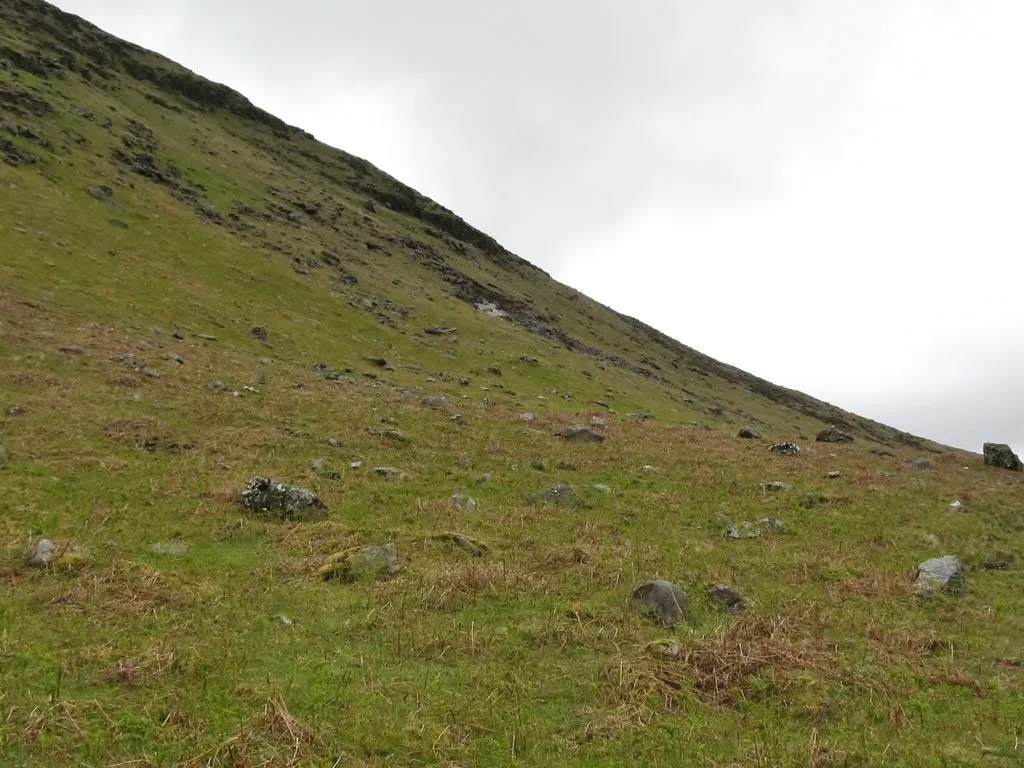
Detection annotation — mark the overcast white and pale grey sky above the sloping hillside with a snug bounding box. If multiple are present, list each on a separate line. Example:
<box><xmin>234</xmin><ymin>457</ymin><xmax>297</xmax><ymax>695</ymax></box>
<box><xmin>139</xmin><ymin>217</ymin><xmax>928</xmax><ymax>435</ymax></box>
<box><xmin>57</xmin><ymin>0</ymin><xmax>1024</xmax><ymax>452</ymax></box>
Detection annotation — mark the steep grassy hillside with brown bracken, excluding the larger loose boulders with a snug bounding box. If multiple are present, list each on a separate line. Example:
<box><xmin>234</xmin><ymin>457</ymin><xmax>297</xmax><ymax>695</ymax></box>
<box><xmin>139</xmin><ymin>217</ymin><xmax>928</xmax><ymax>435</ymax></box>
<box><xmin>0</xmin><ymin>0</ymin><xmax>1024</xmax><ymax>767</ymax></box>
